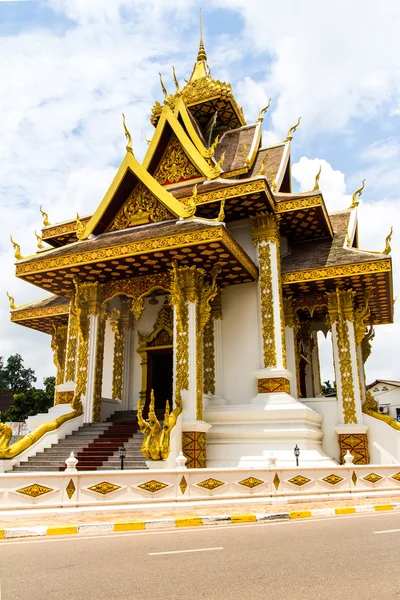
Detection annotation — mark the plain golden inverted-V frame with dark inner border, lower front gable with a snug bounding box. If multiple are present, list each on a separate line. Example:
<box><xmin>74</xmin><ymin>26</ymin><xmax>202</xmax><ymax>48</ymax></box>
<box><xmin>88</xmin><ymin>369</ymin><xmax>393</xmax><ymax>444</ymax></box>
<box><xmin>80</xmin><ymin>152</ymin><xmax>189</xmax><ymax>240</ymax></box>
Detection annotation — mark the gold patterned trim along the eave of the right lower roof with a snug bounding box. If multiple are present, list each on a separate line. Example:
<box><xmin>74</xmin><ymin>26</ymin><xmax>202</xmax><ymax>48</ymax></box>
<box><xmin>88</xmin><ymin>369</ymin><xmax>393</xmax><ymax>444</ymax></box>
<box><xmin>282</xmin><ymin>259</ymin><xmax>392</xmax><ymax>285</ymax></box>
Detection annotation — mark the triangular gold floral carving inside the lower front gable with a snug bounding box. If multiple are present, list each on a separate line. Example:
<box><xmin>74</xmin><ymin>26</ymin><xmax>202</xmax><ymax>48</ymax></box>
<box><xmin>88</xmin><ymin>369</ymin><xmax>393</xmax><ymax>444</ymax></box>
<box><xmin>108</xmin><ymin>182</ymin><xmax>174</xmax><ymax>231</ymax></box>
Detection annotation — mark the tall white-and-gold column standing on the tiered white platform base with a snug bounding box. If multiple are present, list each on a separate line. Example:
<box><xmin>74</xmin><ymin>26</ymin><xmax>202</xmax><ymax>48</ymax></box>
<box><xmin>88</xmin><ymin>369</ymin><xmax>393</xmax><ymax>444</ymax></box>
<box><xmin>251</xmin><ymin>213</ymin><xmax>290</xmax><ymax>393</ymax></box>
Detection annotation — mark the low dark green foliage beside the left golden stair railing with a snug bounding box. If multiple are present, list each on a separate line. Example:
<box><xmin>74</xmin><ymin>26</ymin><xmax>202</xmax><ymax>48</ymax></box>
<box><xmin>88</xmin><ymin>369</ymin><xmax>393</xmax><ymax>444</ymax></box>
<box><xmin>1</xmin><ymin>377</ymin><xmax>56</xmax><ymax>422</ymax></box>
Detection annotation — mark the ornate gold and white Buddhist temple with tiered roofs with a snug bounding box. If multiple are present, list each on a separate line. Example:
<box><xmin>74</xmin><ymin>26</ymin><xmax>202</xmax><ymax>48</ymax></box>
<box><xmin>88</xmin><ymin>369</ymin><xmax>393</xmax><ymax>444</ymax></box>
<box><xmin>5</xmin><ymin>27</ymin><xmax>398</xmax><ymax>468</ymax></box>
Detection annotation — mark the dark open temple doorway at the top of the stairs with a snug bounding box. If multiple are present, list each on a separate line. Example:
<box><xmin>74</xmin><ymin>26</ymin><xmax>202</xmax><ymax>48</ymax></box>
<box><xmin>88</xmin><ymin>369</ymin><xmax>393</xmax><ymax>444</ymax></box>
<box><xmin>145</xmin><ymin>348</ymin><xmax>173</xmax><ymax>415</ymax></box>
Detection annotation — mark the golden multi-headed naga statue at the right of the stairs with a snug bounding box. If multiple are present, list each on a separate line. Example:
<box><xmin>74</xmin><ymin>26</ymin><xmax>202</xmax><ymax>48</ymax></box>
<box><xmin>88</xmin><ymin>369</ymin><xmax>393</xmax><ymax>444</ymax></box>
<box><xmin>137</xmin><ymin>390</ymin><xmax>182</xmax><ymax>460</ymax></box>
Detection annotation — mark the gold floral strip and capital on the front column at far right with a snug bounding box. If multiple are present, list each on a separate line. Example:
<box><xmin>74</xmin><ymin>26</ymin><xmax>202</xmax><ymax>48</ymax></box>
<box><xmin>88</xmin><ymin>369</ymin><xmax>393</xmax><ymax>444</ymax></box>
<box><xmin>327</xmin><ymin>289</ymin><xmax>357</xmax><ymax>424</ymax></box>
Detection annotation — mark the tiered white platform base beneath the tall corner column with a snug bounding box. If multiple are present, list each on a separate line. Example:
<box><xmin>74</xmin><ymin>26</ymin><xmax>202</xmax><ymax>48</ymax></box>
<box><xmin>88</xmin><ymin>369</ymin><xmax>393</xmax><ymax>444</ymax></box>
<box><xmin>204</xmin><ymin>398</ymin><xmax>337</xmax><ymax>468</ymax></box>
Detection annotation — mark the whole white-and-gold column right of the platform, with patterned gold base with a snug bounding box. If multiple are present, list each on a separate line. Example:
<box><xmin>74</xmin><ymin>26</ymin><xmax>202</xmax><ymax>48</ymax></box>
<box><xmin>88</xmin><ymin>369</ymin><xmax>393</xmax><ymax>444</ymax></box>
<box><xmin>327</xmin><ymin>288</ymin><xmax>369</xmax><ymax>464</ymax></box>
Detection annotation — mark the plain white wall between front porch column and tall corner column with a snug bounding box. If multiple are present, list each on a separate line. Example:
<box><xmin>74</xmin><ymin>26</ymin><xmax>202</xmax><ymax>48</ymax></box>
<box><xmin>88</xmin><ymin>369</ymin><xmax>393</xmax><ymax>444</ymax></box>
<box><xmin>222</xmin><ymin>283</ymin><xmax>259</xmax><ymax>404</ymax></box>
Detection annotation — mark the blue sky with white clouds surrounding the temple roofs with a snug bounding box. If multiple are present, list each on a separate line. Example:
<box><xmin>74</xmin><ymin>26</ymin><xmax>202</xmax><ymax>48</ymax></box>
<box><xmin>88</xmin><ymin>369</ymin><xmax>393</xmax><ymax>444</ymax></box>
<box><xmin>0</xmin><ymin>0</ymin><xmax>400</xmax><ymax>384</ymax></box>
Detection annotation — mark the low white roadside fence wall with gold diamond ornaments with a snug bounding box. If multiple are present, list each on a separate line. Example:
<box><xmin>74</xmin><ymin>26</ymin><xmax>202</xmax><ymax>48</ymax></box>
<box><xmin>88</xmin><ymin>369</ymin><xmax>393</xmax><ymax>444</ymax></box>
<box><xmin>0</xmin><ymin>465</ymin><xmax>400</xmax><ymax>510</ymax></box>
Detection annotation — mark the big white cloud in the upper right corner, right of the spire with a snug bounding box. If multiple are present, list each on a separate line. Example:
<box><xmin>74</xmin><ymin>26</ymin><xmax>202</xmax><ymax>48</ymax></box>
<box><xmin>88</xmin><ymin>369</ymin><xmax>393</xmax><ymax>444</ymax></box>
<box><xmin>216</xmin><ymin>0</ymin><xmax>400</xmax><ymax>136</ymax></box>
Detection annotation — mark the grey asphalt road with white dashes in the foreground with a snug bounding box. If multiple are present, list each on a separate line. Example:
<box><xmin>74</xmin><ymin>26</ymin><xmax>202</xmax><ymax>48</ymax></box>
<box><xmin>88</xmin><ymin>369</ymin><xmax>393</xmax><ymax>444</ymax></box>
<box><xmin>0</xmin><ymin>513</ymin><xmax>400</xmax><ymax>600</ymax></box>
